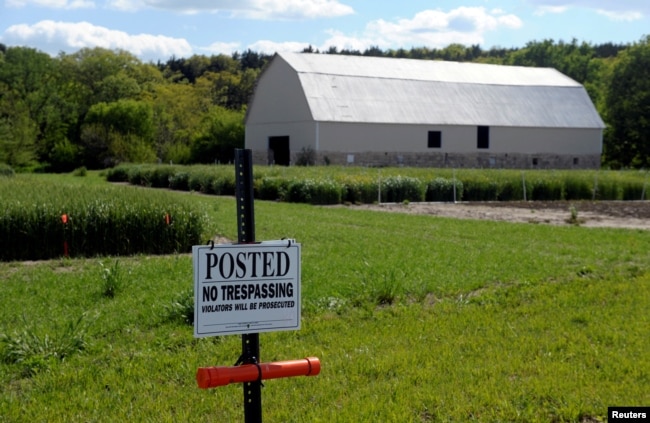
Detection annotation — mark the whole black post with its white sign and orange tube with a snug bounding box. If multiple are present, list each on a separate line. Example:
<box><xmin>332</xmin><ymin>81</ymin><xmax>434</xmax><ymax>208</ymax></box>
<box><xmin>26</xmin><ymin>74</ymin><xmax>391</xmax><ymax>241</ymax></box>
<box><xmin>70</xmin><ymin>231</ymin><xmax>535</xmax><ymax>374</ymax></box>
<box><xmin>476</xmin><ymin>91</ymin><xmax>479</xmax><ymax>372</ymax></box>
<box><xmin>192</xmin><ymin>149</ymin><xmax>320</xmax><ymax>423</ymax></box>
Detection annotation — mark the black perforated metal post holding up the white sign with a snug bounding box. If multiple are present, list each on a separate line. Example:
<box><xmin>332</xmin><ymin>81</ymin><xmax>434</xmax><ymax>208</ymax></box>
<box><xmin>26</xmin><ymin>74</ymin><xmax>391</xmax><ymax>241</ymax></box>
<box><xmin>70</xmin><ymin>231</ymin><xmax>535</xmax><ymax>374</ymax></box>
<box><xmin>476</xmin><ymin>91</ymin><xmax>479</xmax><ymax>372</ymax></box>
<box><xmin>235</xmin><ymin>149</ymin><xmax>262</xmax><ymax>423</ymax></box>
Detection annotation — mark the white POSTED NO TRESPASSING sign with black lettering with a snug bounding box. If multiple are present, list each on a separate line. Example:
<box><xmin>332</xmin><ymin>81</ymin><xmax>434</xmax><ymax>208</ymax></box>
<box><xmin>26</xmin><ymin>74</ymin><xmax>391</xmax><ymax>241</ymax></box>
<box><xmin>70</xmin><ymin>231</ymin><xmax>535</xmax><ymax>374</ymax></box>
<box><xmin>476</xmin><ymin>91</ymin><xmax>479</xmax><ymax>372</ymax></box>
<box><xmin>192</xmin><ymin>240</ymin><xmax>300</xmax><ymax>338</ymax></box>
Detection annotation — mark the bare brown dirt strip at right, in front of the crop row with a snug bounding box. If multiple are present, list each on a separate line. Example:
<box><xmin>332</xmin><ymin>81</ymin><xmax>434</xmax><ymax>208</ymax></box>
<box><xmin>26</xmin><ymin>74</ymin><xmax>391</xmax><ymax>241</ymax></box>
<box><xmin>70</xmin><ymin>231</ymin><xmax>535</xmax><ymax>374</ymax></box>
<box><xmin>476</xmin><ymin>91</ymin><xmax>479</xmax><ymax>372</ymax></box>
<box><xmin>340</xmin><ymin>201</ymin><xmax>650</xmax><ymax>230</ymax></box>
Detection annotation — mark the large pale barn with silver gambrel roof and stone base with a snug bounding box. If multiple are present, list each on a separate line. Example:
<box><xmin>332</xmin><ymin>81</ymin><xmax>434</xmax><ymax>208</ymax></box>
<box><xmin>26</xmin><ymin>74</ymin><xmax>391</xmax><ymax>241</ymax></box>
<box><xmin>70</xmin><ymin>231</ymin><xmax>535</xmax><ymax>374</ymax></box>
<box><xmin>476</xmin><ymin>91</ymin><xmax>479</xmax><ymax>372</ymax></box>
<box><xmin>245</xmin><ymin>53</ymin><xmax>605</xmax><ymax>169</ymax></box>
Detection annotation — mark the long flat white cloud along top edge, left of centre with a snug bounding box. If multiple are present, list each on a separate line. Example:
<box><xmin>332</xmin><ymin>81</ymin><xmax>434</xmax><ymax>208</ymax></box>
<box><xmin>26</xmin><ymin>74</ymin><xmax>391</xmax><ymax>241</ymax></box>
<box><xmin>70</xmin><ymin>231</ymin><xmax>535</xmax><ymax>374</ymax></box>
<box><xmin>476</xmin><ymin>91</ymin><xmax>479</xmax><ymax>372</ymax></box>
<box><xmin>105</xmin><ymin>0</ymin><xmax>354</xmax><ymax>20</ymax></box>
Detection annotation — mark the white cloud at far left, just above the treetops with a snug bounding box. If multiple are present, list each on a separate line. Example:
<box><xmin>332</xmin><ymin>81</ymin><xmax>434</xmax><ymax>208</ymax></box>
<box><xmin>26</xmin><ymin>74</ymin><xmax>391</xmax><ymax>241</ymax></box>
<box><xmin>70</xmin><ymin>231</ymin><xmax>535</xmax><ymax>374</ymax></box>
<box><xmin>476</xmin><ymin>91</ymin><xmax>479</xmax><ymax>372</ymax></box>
<box><xmin>0</xmin><ymin>20</ymin><xmax>192</xmax><ymax>61</ymax></box>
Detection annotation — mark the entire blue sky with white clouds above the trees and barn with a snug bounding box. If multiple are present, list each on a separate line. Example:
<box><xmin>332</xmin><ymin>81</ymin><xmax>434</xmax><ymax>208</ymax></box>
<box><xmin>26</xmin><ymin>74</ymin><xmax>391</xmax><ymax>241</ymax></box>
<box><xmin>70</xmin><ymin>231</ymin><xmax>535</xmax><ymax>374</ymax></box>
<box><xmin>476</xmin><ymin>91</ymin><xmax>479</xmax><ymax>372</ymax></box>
<box><xmin>0</xmin><ymin>0</ymin><xmax>650</xmax><ymax>62</ymax></box>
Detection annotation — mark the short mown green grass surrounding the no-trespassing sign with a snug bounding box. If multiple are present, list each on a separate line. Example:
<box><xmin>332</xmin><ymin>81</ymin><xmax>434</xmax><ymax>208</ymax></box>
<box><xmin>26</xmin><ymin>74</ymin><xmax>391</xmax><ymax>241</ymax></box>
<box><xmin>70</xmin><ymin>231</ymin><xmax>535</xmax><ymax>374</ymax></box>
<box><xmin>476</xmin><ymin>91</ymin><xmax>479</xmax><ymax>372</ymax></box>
<box><xmin>0</xmin><ymin>175</ymin><xmax>650</xmax><ymax>422</ymax></box>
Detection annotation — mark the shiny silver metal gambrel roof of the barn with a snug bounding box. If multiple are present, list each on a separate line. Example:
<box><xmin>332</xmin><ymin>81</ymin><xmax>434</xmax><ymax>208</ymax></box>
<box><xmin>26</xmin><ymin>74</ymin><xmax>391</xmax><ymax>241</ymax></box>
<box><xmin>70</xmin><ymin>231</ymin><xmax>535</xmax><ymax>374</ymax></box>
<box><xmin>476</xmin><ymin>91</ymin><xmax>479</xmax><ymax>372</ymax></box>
<box><xmin>276</xmin><ymin>53</ymin><xmax>604</xmax><ymax>128</ymax></box>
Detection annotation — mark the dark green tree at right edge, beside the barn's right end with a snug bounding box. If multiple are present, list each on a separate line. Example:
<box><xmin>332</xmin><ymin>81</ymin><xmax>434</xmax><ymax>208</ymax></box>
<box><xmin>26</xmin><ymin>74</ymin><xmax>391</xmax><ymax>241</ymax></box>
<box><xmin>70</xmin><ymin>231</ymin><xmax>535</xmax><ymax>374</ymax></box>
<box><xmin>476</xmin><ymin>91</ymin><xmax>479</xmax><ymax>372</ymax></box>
<box><xmin>604</xmin><ymin>36</ymin><xmax>650</xmax><ymax>168</ymax></box>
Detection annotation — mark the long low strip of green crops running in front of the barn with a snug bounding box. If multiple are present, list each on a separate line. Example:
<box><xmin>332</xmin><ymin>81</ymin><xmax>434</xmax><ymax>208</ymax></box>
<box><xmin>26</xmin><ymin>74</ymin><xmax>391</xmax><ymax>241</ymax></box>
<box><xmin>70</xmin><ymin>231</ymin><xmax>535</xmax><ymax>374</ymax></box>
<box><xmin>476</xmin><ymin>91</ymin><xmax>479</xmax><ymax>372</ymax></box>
<box><xmin>107</xmin><ymin>165</ymin><xmax>648</xmax><ymax>204</ymax></box>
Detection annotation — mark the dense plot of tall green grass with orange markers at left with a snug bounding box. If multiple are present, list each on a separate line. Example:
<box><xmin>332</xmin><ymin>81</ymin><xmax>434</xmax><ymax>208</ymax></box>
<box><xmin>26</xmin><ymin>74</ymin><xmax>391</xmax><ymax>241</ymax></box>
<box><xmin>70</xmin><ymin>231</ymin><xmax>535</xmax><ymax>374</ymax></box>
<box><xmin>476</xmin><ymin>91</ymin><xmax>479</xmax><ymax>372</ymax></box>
<box><xmin>0</xmin><ymin>175</ymin><xmax>203</xmax><ymax>260</ymax></box>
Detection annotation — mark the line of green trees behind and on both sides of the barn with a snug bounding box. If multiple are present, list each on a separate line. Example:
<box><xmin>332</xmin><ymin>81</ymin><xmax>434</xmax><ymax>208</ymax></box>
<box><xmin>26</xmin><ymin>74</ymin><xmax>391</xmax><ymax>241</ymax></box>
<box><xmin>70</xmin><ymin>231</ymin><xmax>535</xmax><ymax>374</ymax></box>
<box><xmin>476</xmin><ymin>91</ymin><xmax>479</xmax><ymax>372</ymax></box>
<box><xmin>0</xmin><ymin>36</ymin><xmax>650</xmax><ymax>172</ymax></box>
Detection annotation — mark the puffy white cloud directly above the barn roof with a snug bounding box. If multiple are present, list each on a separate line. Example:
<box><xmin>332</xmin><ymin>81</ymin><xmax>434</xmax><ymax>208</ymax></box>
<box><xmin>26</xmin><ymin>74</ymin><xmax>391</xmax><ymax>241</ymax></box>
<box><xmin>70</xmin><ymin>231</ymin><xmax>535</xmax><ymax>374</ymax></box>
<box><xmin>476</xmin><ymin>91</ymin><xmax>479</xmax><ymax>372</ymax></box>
<box><xmin>321</xmin><ymin>7</ymin><xmax>523</xmax><ymax>50</ymax></box>
